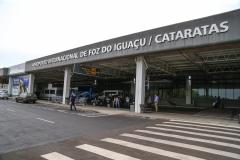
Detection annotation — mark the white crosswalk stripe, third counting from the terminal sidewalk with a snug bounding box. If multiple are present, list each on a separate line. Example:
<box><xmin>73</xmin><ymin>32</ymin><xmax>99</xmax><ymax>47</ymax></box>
<box><xmin>156</xmin><ymin>124</ymin><xmax>240</xmax><ymax>136</ymax></box>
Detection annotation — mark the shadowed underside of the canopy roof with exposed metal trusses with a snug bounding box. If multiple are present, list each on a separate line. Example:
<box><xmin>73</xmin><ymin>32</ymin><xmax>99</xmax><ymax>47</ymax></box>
<box><xmin>33</xmin><ymin>42</ymin><xmax>240</xmax><ymax>86</ymax></box>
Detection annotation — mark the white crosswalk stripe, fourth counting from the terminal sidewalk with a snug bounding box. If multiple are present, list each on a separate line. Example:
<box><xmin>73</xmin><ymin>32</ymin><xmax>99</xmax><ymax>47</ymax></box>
<box><xmin>146</xmin><ymin>127</ymin><xmax>240</xmax><ymax>142</ymax></box>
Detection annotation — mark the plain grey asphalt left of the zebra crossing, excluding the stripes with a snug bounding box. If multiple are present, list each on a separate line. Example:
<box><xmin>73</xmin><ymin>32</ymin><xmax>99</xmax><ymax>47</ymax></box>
<box><xmin>0</xmin><ymin>100</ymin><xmax>156</xmax><ymax>153</ymax></box>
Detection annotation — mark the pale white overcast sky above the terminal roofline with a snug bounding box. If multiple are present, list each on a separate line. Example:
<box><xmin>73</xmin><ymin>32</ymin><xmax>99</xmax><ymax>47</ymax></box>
<box><xmin>0</xmin><ymin>0</ymin><xmax>240</xmax><ymax>68</ymax></box>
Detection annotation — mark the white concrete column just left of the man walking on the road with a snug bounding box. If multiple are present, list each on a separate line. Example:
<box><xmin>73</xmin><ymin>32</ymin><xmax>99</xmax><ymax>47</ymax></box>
<box><xmin>62</xmin><ymin>67</ymin><xmax>71</xmax><ymax>104</ymax></box>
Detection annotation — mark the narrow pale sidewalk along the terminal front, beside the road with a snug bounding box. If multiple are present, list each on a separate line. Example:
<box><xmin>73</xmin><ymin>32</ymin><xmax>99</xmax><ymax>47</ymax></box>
<box><xmin>37</xmin><ymin>100</ymin><xmax>240</xmax><ymax>127</ymax></box>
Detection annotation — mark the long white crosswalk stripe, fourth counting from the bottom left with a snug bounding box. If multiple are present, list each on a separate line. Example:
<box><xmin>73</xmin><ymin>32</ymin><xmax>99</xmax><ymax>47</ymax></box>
<box><xmin>121</xmin><ymin>133</ymin><xmax>240</xmax><ymax>159</ymax></box>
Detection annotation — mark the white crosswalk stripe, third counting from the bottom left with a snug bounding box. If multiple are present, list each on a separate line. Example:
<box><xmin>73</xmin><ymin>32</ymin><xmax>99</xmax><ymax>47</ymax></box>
<box><xmin>102</xmin><ymin>138</ymin><xmax>204</xmax><ymax>160</ymax></box>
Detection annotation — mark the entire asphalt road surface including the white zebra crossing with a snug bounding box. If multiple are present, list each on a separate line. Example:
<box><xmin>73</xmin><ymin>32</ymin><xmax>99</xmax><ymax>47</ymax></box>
<box><xmin>0</xmin><ymin>101</ymin><xmax>240</xmax><ymax>160</ymax></box>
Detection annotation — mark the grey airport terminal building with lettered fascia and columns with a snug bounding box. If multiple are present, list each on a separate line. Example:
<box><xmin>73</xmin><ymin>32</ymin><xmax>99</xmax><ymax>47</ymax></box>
<box><xmin>0</xmin><ymin>9</ymin><xmax>240</xmax><ymax>113</ymax></box>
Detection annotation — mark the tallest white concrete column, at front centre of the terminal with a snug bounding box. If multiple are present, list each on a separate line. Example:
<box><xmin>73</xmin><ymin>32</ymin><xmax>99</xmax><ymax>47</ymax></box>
<box><xmin>135</xmin><ymin>57</ymin><xmax>146</xmax><ymax>113</ymax></box>
